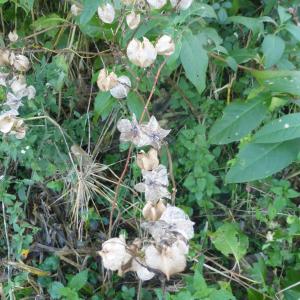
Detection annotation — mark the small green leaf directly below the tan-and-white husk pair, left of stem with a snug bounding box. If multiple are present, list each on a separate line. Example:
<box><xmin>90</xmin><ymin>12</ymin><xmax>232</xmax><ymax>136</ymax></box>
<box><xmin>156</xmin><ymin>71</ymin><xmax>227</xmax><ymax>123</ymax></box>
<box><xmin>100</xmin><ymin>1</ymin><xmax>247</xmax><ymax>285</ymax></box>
<box><xmin>93</xmin><ymin>92</ymin><xmax>116</xmax><ymax>122</ymax></box>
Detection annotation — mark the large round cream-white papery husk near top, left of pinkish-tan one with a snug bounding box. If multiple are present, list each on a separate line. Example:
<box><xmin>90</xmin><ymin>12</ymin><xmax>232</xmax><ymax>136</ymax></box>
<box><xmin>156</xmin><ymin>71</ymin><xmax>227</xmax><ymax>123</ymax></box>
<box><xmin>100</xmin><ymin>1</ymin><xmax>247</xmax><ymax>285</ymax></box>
<box><xmin>127</xmin><ymin>37</ymin><xmax>157</xmax><ymax>68</ymax></box>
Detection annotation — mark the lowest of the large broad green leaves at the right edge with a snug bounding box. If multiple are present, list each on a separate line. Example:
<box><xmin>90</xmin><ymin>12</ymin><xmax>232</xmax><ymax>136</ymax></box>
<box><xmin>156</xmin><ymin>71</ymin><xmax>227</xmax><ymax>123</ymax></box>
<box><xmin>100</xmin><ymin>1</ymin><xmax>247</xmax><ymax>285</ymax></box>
<box><xmin>226</xmin><ymin>139</ymin><xmax>300</xmax><ymax>183</ymax></box>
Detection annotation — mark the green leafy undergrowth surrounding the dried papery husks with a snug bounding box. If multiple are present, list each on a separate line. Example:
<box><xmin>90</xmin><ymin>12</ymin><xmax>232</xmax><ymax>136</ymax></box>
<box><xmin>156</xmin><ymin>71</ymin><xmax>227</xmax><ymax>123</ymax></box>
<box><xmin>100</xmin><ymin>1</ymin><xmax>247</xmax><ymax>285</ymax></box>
<box><xmin>0</xmin><ymin>0</ymin><xmax>300</xmax><ymax>300</ymax></box>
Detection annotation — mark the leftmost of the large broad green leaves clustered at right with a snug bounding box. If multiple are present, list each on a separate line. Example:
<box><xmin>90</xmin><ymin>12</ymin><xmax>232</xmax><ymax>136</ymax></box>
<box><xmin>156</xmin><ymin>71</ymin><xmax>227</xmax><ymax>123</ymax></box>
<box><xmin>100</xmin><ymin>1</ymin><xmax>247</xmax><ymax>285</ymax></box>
<box><xmin>209</xmin><ymin>95</ymin><xmax>268</xmax><ymax>145</ymax></box>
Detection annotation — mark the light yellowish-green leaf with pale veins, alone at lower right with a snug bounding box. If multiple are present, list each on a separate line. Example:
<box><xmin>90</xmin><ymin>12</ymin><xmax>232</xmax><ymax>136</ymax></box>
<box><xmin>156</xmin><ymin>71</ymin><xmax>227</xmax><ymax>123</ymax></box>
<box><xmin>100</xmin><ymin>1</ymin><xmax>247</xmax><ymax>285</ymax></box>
<box><xmin>211</xmin><ymin>223</ymin><xmax>249</xmax><ymax>260</ymax></box>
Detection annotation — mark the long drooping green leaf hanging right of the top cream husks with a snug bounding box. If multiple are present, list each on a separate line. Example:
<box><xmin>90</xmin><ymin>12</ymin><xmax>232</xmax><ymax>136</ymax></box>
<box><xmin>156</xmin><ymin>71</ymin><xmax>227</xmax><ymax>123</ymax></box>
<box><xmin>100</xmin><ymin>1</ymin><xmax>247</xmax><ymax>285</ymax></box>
<box><xmin>180</xmin><ymin>34</ymin><xmax>208</xmax><ymax>94</ymax></box>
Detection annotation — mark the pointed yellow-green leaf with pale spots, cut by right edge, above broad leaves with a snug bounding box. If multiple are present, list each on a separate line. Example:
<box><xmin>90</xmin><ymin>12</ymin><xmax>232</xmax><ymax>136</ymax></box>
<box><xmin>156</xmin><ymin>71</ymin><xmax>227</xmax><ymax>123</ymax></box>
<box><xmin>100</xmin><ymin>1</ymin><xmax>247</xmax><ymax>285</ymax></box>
<box><xmin>252</xmin><ymin>71</ymin><xmax>300</xmax><ymax>96</ymax></box>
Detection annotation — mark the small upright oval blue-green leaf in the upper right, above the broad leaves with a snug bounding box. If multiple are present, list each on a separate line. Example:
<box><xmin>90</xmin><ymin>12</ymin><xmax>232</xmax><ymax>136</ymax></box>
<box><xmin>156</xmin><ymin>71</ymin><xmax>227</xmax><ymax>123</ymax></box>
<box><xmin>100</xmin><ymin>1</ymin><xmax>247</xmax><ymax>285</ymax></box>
<box><xmin>262</xmin><ymin>34</ymin><xmax>285</xmax><ymax>68</ymax></box>
